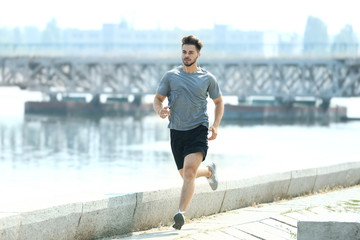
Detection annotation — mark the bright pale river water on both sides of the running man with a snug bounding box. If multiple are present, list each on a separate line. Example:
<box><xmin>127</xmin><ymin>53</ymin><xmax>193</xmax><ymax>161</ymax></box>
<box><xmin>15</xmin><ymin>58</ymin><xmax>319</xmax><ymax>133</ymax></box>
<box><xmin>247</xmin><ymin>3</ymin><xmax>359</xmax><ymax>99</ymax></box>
<box><xmin>0</xmin><ymin>89</ymin><xmax>360</xmax><ymax>205</ymax></box>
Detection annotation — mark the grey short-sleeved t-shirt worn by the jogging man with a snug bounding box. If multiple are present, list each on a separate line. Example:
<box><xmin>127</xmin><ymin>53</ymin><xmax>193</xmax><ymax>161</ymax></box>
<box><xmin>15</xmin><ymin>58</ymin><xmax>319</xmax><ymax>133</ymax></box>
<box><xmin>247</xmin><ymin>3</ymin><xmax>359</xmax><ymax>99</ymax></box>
<box><xmin>157</xmin><ymin>66</ymin><xmax>221</xmax><ymax>131</ymax></box>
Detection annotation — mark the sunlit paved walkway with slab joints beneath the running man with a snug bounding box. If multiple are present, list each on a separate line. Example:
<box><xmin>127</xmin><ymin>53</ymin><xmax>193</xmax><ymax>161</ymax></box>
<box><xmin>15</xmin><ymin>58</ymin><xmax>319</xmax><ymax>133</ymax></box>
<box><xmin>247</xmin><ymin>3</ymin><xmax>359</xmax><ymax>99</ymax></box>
<box><xmin>101</xmin><ymin>185</ymin><xmax>360</xmax><ymax>240</ymax></box>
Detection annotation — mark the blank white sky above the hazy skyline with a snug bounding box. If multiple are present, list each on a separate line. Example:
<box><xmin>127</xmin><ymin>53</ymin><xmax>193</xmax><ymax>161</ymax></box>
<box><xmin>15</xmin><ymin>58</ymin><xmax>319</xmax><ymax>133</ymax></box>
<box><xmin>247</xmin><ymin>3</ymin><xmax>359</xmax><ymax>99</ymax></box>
<box><xmin>0</xmin><ymin>0</ymin><xmax>360</xmax><ymax>34</ymax></box>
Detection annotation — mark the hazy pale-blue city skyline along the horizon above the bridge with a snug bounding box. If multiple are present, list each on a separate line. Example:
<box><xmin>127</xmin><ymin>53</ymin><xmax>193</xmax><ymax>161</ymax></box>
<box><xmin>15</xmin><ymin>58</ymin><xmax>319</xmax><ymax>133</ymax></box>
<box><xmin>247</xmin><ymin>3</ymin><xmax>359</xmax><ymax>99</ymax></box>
<box><xmin>0</xmin><ymin>17</ymin><xmax>359</xmax><ymax>58</ymax></box>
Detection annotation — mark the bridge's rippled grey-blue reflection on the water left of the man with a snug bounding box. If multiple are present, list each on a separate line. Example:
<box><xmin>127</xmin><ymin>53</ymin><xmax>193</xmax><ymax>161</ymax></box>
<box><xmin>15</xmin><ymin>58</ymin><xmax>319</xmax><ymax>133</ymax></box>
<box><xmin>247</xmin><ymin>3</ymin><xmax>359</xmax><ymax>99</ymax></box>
<box><xmin>0</xmin><ymin>115</ymin><xmax>169</xmax><ymax>168</ymax></box>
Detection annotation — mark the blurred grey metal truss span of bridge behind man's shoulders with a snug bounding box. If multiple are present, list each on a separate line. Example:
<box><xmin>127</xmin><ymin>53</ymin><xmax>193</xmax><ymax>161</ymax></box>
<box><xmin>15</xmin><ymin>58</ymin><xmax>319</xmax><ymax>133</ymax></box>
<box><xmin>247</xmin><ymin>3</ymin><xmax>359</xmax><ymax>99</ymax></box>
<box><xmin>0</xmin><ymin>58</ymin><xmax>360</xmax><ymax>101</ymax></box>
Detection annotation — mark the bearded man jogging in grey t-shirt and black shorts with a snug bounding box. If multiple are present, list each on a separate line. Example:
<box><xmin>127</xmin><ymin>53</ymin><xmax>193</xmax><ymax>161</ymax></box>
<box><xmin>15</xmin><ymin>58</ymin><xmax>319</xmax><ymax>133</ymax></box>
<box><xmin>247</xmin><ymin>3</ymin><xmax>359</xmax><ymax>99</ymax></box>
<box><xmin>153</xmin><ymin>36</ymin><xmax>224</xmax><ymax>230</ymax></box>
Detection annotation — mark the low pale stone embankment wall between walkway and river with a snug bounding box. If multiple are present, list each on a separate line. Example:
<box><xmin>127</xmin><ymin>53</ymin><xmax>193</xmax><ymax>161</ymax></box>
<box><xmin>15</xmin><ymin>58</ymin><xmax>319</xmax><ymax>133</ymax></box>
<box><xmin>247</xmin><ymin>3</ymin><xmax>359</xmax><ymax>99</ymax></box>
<box><xmin>0</xmin><ymin>162</ymin><xmax>360</xmax><ymax>240</ymax></box>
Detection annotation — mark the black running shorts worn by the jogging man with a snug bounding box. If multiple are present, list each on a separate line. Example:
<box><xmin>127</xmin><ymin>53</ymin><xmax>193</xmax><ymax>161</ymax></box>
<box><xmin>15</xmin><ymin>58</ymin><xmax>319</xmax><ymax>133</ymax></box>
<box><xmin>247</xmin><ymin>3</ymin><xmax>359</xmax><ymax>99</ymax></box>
<box><xmin>170</xmin><ymin>125</ymin><xmax>209</xmax><ymax>170</ymax></box>
